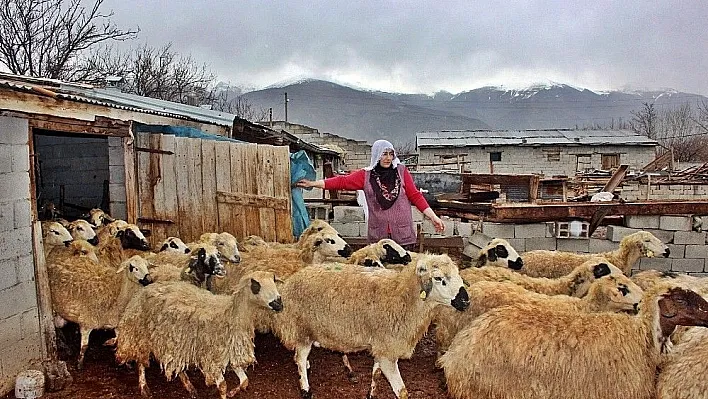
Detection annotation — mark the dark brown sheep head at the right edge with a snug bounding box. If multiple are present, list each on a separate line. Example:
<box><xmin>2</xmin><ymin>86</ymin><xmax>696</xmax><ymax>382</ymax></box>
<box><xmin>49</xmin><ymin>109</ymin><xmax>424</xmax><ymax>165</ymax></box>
<box><xmin>658</xmin><ymin>286</ymin><xmax>708</xmax><ymax>337</ymax></box>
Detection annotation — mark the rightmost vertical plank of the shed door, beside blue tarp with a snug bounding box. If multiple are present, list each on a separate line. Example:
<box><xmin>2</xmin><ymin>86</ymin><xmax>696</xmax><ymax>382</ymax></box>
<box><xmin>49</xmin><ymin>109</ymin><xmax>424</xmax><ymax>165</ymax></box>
<box><xmin>273</xmin><ymin>147</ymin><xmax>295</xmax><ymax>243</ymax></box>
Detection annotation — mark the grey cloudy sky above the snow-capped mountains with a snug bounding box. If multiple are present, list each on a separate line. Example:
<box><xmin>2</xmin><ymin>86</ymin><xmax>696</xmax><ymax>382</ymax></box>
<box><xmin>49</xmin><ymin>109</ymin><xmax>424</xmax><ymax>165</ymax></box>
<box><xmin>104</xmin><ymin>0</ymin><xmax>708</xmax><ymax>95</ymax></box>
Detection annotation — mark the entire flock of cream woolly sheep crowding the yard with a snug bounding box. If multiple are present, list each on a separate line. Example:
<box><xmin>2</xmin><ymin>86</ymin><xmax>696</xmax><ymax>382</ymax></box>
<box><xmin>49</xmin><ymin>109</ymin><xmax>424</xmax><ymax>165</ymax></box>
<box><xmin>43</xmin><ymin>210</ymin><xmax>708</xmax><ymax>399</ymax></box>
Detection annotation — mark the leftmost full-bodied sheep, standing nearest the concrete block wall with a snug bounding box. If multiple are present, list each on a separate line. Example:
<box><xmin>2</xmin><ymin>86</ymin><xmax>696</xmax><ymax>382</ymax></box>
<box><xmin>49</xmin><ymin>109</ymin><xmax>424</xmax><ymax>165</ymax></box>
<box><xmin>47</xmin><ymin>256</ymin><xmax>152</xmax><ymax>368</ymax></box>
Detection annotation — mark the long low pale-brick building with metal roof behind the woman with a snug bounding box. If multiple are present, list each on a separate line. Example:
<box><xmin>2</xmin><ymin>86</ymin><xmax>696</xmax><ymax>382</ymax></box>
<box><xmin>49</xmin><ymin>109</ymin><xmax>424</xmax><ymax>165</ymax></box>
<box><xmin>416</xmin><ymin>130</ymin><xmax>658</xmax><ymax>177</ymax></box>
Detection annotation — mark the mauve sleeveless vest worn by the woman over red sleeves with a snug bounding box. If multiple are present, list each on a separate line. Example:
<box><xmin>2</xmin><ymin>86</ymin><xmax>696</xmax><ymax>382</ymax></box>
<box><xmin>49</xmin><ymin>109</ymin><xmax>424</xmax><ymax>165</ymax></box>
<box><xmin>364</xmin><ymin>165</ymin><xmax>416</xmax><ymax>245</ymax></box>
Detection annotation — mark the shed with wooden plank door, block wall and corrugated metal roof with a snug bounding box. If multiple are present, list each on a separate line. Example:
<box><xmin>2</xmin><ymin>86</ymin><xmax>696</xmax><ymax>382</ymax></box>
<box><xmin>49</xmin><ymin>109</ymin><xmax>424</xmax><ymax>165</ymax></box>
<box><xmin>0</xmin><ymin>73</ymin><xmax>333</xmax><ymax>395</ymax></box>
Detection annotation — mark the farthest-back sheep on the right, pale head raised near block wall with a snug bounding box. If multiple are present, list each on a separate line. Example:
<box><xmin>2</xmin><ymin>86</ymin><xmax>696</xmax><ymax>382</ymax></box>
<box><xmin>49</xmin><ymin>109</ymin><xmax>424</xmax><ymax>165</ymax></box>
<box><xmin>519</xmin><ymin>231</ymin><xmax>670</xmax><ymax>278</ymax></box>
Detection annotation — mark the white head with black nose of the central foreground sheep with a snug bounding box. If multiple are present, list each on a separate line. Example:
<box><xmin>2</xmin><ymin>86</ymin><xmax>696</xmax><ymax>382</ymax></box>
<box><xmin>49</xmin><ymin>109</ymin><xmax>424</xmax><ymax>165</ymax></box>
<box><xmin>416</xmin><ymin>254</ymin><xmax>470</xmax><ymax>311</ymax></box>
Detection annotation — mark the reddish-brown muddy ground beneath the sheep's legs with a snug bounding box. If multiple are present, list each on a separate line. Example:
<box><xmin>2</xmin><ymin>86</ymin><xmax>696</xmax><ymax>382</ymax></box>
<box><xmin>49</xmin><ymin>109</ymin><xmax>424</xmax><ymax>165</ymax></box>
<box><xmin>2</xmin><ymin>333</ymin><xmax>450</xmax><ymax>399</ymax></box>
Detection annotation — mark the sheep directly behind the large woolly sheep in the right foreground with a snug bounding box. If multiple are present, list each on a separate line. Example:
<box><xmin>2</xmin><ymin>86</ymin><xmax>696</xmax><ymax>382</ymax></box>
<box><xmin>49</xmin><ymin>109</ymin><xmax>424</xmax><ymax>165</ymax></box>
<box><xmin>434</xmin><ymin>266</ymin><xmax>643</xmax><ymax>352</ymax></box>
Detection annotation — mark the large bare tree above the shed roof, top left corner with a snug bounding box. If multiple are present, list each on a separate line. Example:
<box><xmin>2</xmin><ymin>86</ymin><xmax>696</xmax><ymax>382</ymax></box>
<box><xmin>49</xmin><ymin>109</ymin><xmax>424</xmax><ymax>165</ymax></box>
<box><xmin>0</xmin><ymin>0</ymin><xmax>138</xmax><ymax>80</ymax></box>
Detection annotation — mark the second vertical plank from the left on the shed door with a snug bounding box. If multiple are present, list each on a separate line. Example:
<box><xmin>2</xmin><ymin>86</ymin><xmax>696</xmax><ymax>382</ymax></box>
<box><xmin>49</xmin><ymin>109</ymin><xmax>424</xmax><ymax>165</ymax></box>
<box><xmin>155</xmin><ymin>134</ymin><xmax>181</xmax><ymax>238</ymax></box>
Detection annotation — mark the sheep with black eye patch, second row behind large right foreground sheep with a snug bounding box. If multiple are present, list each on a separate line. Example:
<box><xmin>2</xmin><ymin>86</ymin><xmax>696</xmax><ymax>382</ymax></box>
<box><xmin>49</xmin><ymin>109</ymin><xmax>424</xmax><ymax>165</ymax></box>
<box><xmin>460</xmin><ymin>257</ymin><xmax>624</xmax><ymax>297</ymax></box>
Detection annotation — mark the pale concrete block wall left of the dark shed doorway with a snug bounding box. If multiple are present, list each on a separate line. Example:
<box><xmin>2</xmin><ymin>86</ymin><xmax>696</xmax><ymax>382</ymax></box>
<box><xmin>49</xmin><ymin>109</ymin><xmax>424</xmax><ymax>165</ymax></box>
<box><xmin>0</xmin><ymin>117</ymin><xmax>41</xmax><ymax>395</ymax></box>
